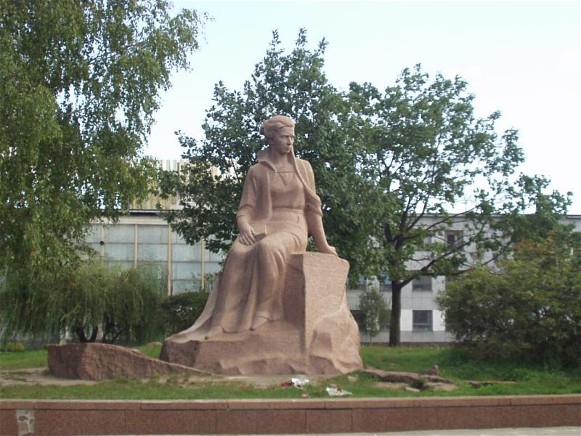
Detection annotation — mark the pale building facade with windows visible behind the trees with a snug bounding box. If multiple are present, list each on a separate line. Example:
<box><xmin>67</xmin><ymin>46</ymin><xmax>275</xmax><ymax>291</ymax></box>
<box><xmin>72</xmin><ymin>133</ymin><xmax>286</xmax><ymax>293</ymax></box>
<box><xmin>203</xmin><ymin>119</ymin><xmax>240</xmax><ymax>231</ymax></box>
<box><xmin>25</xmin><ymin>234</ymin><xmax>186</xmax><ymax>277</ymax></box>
<box><xmin>87</xmin><ymin>161</ymin><xmax>581</xmax><ymax>344</ymax></box>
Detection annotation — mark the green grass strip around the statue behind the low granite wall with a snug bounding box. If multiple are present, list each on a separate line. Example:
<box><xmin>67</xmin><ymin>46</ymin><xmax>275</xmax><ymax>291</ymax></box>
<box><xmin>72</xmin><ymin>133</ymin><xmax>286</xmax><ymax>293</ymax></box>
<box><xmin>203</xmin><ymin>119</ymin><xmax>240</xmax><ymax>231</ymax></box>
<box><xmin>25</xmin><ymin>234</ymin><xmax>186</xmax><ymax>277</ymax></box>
<box><xmin>0</xmin><ymin>345</ymin><xmax>581</xmax><ymax>400</ymax></box>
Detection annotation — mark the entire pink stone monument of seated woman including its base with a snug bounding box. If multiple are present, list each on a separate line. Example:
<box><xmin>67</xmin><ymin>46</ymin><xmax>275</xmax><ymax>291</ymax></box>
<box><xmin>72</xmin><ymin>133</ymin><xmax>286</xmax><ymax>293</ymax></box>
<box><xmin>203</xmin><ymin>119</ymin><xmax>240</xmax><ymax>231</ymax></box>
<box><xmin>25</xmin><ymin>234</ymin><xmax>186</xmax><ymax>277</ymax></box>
<box><xmin>161</xmin><ymin>115</ymin><xmax>361</xmax><ymax>374</ymax></box>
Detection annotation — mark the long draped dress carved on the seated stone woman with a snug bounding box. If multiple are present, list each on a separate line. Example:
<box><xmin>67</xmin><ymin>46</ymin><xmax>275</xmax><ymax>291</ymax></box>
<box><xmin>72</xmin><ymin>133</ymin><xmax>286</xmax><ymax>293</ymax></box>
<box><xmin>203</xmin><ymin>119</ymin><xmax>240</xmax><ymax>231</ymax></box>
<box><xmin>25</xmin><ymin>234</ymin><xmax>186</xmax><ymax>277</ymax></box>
<box><xmin>175</xmin><ymin>148</ymin><xmax>322</xmax><ymax>340</ymax></box>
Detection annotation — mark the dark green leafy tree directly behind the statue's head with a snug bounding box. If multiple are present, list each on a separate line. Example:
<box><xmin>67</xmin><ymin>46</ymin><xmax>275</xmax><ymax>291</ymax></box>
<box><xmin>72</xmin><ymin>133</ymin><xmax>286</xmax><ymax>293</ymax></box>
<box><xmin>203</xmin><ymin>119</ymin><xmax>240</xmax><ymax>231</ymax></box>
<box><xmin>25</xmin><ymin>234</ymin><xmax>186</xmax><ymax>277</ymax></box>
<box><xmin>161</xmin><ymin>30</ymin><xmax>370</xmax><ymax>277</ymax></box>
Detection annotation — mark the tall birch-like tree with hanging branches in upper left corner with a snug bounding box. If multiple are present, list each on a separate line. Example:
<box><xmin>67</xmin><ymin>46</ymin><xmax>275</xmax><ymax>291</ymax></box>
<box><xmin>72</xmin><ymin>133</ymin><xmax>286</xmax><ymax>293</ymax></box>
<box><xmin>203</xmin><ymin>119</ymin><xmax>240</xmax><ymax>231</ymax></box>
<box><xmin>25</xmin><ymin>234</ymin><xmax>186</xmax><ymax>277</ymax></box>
<box><xmin>0</xmin><ymin>0</ymin><xmax>201</xmax><ymax>286</ymax></box>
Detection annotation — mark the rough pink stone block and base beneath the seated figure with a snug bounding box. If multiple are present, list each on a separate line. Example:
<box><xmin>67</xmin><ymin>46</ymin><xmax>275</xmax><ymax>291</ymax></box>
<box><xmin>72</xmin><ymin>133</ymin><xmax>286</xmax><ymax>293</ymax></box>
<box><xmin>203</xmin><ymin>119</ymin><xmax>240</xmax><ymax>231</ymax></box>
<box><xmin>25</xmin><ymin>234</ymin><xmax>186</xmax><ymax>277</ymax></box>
<box><xmin>161</xmin><ymin>253</ymin><xmax>363</xmax><ymax>375</ymax></box>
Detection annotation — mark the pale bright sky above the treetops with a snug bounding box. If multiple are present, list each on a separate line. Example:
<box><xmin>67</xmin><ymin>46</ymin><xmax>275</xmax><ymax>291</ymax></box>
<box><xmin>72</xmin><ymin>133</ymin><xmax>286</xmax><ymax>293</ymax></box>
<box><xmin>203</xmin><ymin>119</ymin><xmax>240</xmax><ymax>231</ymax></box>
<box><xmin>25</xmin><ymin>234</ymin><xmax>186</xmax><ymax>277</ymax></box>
<box><xmin>146</xmin><ymin>0</ymin><xmax>581</xmax><ymax>215</ymax></box>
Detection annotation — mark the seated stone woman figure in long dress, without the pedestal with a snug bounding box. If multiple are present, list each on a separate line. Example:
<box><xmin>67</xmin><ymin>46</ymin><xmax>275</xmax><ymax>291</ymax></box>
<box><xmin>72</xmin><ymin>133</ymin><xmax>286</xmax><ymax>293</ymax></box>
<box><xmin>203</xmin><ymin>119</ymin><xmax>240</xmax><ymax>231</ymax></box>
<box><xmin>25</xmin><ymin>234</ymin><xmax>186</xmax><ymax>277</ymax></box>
<box><xmin>177</xmin><ymin>115</ymin><xmax>337</xmax><ymax>339</ymax></box>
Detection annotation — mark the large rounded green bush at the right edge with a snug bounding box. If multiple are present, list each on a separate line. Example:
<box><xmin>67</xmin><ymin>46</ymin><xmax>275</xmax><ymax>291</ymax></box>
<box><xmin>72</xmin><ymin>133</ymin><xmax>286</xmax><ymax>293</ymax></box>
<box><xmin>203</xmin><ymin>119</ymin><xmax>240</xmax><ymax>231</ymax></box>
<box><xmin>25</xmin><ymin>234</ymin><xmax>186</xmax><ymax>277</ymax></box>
<box><xmin>438</xmin><ymin>229</ymin><xmax>581</xmax><ymax>365</ymax></box>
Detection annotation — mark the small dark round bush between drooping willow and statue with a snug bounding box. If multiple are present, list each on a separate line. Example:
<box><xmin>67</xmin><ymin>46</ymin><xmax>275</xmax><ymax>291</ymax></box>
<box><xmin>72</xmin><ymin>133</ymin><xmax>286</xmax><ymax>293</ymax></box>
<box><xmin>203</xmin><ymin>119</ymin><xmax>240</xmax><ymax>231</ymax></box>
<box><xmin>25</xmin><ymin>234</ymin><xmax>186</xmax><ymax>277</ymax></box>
<box><xmin>160</xmin><ymin>291</ymin><xmax>208</xmax><ymax>335</ymax></box>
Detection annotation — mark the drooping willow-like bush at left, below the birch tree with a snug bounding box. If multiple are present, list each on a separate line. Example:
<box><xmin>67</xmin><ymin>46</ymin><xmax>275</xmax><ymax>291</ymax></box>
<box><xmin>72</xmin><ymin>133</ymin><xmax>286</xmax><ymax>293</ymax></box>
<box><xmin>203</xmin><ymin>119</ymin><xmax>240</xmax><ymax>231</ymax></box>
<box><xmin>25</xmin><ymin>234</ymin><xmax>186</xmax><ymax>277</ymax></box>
<box><xmin>0</xmin><ymin>262</ymin><xmax>168</xmax><ymax>342</ymax></box>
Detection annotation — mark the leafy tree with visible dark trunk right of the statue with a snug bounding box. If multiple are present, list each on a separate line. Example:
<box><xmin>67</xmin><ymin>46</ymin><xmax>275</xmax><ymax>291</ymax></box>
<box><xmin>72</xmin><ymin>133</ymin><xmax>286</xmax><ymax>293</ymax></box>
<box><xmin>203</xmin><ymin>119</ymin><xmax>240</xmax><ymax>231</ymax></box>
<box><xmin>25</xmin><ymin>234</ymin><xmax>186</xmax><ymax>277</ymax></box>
<box><xmin>342</xmin><ymin>65</ymin><xmax>569</xmax><ymax>345</ymax></box>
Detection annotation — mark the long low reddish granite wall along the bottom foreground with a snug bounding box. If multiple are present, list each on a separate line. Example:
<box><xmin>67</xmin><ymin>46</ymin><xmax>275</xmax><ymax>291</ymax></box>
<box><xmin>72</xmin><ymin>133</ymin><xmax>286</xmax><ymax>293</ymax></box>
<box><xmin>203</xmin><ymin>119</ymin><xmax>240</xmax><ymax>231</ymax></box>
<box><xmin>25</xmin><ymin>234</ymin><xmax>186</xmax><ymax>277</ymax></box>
<box><xmin>0</xmin><ymin>395</ymin><xmax>581</xmax><ymax>436</ymax></box>
